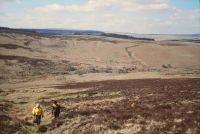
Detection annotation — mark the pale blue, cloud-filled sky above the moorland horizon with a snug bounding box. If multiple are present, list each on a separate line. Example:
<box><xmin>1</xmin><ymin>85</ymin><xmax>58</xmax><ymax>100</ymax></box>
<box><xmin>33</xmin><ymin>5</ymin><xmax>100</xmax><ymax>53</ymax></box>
<box><xmin>0</xmin><ymin>0</ymin><xmax>200</xmax><ymax>34</ymax></box>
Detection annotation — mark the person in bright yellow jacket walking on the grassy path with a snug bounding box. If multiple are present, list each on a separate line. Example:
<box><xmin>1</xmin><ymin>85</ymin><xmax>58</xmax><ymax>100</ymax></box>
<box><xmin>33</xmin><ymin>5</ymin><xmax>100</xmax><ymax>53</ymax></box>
<box><xmin>32</xmin><ymin>103</ymin><xmax>44</xmax><ymax>125</ymax></box>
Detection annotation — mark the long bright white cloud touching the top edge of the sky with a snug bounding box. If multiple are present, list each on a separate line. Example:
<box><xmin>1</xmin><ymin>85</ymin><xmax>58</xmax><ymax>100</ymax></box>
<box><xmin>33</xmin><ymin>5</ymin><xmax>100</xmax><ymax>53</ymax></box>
<box><xmin>34</xmin><ymin>0</ymin><xmax>170</xmax><ymax>12</ymax></box>
